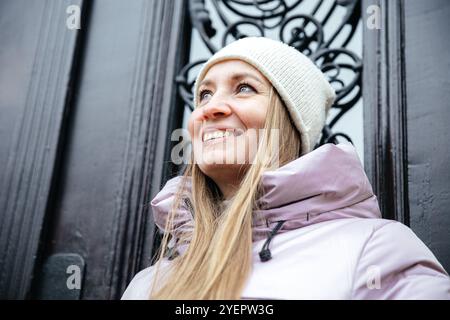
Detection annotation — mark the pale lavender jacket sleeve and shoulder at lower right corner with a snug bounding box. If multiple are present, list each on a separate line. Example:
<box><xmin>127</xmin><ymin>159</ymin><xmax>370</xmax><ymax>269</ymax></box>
<box><xmin>352</xmin><ymin>221</ymin><xmax>450</xmax><ymax>300</ymax></box>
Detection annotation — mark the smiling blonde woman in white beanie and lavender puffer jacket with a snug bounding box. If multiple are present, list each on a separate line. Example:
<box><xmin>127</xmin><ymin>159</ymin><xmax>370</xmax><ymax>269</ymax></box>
<box><xmin>122</xmin><ymin>37</ymin><xmax>450</xmax><ymax>299</ymax></box>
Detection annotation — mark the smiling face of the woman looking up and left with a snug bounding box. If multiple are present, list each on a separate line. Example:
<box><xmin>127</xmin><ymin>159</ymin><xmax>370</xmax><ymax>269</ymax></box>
<box><xmin>188</xmin><ymin>60</ymin><xmax>271</xmax><ymax>196</ymax></box>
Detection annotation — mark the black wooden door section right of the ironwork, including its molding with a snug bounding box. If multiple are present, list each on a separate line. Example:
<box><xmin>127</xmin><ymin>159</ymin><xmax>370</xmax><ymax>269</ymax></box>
<box><xmin>363</xmin><ymin>0</ymin><xmax>450</xmax><ymax>271</ymax></box>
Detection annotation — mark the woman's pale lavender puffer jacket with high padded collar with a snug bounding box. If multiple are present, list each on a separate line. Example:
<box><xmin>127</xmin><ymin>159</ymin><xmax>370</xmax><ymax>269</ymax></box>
<box><xmin>122</xmin><ymin>144</ymin><xmax>450</xmax><ymax>299</ymax></box>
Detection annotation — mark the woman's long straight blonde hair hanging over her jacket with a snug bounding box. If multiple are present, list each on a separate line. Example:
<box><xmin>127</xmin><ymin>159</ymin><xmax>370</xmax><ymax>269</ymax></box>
<box><xmin>149</xmin><ymin>87</ymin><xmax>301</xmax><ymax>300</ymax></box>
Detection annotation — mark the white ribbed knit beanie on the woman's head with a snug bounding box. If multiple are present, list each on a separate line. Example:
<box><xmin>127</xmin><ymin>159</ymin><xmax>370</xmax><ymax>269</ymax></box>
<box><xmin>194</xmin><ymin>37</ymin><xmax>336</xmax><ymax>155</ymax></box>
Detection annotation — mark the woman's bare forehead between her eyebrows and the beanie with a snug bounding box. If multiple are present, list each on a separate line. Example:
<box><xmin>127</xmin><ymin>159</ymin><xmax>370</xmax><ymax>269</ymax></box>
<box><xmin>200</xmin><ymin>60</ymin><xmax>269</xmax><ymax>85</ymax></box>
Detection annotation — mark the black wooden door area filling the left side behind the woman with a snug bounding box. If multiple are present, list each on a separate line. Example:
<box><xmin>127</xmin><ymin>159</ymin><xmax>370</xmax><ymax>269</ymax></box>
<box><xmin>0</xmin><ymin>0</ymin><xmax>190</xmax><ymax>299</ymax></box>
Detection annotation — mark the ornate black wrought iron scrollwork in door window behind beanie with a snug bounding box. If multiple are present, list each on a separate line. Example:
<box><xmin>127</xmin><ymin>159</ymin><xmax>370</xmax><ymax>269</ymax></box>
<box><xmin>176</xmin><ymin>0</ymin><xmax>362</xmax><ymax>147</ymax></box>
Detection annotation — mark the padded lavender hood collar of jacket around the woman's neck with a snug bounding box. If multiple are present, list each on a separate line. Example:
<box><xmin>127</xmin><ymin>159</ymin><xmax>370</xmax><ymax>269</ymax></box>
<box><xmin>151</xmin><ymin>143</ymin><xmax>381</xmax><ymax>258</ymax></box>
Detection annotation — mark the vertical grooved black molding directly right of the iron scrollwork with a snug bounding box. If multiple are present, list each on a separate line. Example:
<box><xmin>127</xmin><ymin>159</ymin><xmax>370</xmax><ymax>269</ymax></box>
<box><xmin>362</xmin><ymin>0</ymin><xmax>409</xmax><ymax>225</ymax></box>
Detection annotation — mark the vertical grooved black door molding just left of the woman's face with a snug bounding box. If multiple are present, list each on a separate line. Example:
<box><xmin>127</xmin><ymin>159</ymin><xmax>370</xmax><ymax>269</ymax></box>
<box><xmin>108</xmin><ymin>0</ymin><xmax>191</xmax><ymax>299</ymax></box>
